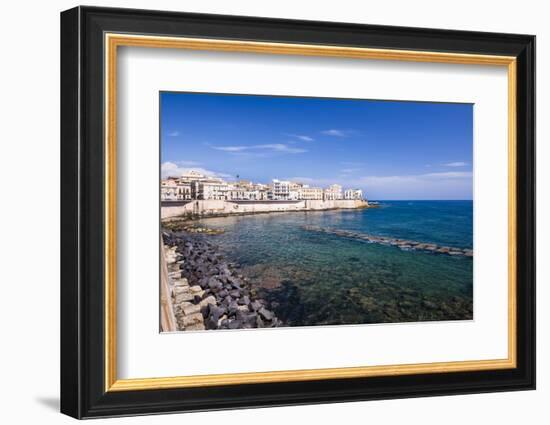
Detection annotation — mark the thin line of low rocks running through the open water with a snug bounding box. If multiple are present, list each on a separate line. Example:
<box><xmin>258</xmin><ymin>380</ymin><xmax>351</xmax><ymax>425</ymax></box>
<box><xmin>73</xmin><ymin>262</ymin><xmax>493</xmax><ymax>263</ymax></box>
<box><xmin>303</xmin><ymin>226</ymin><xmax>474</xmax><ymax>257</ymax></box>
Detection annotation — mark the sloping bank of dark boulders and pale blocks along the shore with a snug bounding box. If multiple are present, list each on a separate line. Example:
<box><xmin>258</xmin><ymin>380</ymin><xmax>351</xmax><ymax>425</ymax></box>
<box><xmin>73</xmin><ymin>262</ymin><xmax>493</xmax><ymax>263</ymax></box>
<box><xmin>162</xmin><ymin>229</ymin><xmax>281</xmax><ymax>331</ymax></box>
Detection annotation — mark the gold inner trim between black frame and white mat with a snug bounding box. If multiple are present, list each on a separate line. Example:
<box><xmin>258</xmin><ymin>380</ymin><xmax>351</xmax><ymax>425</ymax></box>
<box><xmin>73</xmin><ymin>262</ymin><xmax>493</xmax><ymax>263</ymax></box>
<box><xmin>104</xmin><ymin>33</ymin><xmax>517</xmax><ymax>391</ymax></box>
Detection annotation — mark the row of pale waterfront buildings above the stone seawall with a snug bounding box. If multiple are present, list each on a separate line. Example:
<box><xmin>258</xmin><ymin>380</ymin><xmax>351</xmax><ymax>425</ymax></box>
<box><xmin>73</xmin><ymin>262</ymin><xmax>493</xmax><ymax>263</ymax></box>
<box><xmin>160</xmin><ymin>171</ymin><xmax>363</xmax><ymax>201</ymax></box>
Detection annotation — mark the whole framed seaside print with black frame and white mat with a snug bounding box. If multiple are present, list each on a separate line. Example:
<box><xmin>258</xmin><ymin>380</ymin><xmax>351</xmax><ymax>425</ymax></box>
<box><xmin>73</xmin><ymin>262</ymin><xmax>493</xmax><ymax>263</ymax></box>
<box><xmin>61</xmin><ymin>7</ymin><xmax>535</xmax><ymax>418</ymax></box>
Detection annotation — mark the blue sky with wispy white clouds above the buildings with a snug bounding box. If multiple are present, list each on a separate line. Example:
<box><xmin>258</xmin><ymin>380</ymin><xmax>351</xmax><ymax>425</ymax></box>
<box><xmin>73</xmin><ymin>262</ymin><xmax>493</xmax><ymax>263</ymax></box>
<box><xmin>160</xmin><ymin>92</ymin><xmax>473</xmax><ymax>200</ymax></box>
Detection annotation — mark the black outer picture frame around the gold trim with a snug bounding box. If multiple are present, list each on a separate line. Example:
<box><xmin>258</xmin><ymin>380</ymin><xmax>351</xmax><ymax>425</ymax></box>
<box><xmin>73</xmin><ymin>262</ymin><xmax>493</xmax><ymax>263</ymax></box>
<box><xmin>61</xmin><ymin>7</ymin><xmax>535</xmax><ymax>418</ymax></box>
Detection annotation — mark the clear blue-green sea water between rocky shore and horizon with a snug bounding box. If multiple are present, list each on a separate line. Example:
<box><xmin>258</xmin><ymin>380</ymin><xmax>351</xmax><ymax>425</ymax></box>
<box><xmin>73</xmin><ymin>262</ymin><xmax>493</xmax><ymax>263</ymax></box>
<box><xmin>201</xmin><ymin>201</ymin><xmax>473</xmax><ymax>326</ymax></box>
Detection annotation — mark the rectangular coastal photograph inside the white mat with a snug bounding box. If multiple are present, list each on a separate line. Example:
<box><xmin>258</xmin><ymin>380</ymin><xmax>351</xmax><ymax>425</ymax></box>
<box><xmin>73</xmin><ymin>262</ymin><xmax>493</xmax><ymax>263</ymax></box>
<box><xmin>160</xmin><ymin>92</ymin><xmax>474</xmax><ymax>331</ymax></box>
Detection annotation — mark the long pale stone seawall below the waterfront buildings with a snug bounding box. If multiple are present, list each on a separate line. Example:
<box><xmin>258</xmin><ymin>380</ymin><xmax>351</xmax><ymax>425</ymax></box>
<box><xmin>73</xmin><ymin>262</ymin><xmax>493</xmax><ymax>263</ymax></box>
<box><xmin>161</xmin><ymin>199</ymin><xmax>368</xmax><ymax>218</ymax></box>
